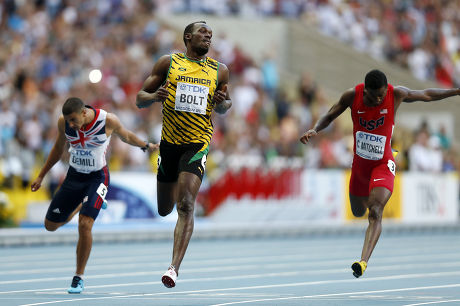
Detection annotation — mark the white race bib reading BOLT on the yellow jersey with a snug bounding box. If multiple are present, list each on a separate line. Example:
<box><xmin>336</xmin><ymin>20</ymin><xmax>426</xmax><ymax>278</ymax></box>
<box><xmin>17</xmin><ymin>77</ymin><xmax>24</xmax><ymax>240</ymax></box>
<box><xmin>175</xmin><ymin>82</ymin><xmax>209</xmax><ymax>115</ymax></box>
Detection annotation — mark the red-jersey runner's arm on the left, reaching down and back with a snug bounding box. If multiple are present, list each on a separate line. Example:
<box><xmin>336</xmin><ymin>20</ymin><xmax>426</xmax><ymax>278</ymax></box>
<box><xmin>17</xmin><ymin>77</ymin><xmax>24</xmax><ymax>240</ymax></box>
<box><xmin>300</xmin><ymin>88</ymin><xmax>355</xmax><ymax>144</ymax></box>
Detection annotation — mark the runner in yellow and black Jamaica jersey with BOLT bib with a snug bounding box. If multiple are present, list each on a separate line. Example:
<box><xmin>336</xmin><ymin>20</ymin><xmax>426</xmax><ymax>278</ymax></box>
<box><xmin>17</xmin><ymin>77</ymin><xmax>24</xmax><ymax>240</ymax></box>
<box><xmin>136</xmin><ymin>21</ymin><xmax>232</xmax><ymax>288</ymax></box>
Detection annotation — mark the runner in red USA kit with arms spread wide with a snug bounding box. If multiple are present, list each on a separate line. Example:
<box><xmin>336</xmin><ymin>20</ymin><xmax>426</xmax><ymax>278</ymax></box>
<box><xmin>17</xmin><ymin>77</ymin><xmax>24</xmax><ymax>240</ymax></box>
<box><xmin>300</xmin><ymin>70</ymin><xmax>460</xmax><ymax>277</ymax></box>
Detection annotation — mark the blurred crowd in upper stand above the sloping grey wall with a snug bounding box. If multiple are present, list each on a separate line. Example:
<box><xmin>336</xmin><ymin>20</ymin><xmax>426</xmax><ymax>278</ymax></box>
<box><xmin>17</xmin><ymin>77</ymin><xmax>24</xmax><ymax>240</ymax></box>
<box><xmin>157</xmin><ymin>0</ymin><xmax>460</xmax><ymax>87</ymax></box>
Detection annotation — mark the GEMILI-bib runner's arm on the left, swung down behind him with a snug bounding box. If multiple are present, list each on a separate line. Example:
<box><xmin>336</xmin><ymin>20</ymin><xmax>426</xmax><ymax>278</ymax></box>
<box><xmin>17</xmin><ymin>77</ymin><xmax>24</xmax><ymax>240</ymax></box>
<box><xmin>30</xmin><ymin>115</ymin><xmax>66</xmax><ymax>191</ymax></box>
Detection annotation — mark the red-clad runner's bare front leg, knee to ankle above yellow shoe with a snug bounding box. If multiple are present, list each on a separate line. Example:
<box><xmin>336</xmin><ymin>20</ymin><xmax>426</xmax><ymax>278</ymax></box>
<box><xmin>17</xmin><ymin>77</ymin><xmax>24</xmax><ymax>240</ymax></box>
<box><xmin>361</xmin><ymin>187</ymin><xmax>391</xmax><ymax>263</ymax></box>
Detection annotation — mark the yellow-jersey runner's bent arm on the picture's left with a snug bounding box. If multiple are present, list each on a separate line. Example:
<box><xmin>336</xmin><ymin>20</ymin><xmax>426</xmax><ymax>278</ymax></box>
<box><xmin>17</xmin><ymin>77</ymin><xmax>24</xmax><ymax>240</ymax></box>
<box><xmin>136</xmin><ymin>55</ymin><xmax>171</xmax><ymax>108</ymax></box>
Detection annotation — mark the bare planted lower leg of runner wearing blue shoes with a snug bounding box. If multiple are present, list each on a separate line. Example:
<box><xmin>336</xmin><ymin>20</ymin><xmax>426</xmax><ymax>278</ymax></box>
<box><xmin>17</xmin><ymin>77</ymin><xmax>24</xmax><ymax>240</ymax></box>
<box><xmin>76</xmin><ymin>214</ymin><xmax>94</xmax><ymax>275</ymax></box>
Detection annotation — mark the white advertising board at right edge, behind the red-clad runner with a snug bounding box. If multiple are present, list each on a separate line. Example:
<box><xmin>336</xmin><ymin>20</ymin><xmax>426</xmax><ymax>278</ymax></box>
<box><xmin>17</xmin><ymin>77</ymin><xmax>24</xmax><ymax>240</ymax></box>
<box><xmin>401</xmin><ymin>172</ymin><xmax>459</xmax><ymax>223</ymax></box>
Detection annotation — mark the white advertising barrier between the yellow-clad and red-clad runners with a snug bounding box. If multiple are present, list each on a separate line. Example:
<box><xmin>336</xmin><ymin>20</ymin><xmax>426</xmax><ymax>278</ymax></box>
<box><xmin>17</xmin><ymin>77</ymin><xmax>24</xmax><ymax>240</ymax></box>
<box><xmin>210</xmin><ymin>169</ymin><xmax>345</xmax><ymax>225</ymax></box>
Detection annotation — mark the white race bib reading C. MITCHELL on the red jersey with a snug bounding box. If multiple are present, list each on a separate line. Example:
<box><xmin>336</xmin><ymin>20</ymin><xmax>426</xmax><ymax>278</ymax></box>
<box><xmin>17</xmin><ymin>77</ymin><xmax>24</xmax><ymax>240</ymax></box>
<box><xmin>356</xmin><ymin>131</ymin><xmax>387</xmax><ymax>160</ymax></box>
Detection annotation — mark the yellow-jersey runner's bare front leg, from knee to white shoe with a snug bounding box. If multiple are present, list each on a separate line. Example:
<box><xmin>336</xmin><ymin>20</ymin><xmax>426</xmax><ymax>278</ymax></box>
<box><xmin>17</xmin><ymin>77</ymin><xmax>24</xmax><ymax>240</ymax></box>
<box><xmin>171</xmin><ymin>172</ymin><xmax>201</xmax><ymax>273</ymax></box>
